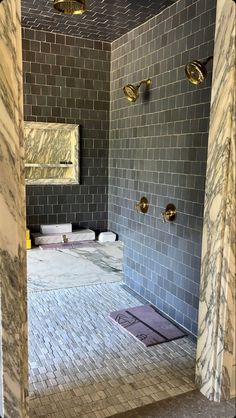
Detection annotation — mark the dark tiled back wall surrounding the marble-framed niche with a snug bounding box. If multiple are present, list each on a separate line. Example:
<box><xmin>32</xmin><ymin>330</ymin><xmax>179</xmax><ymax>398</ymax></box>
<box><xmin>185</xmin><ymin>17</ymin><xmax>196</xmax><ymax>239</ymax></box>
<box><xmin>23</xmin><ymin>28</ymin><xmax>111</xmax><ymax>230</ymax></box>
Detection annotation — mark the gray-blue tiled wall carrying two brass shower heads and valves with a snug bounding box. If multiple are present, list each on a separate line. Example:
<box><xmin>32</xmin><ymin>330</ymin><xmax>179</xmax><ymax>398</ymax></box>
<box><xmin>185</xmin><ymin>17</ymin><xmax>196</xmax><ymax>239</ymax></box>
<box><xmin>108</xmin><ymin>0</ymin><xmax>216</xmax><ymax>336</ymax></box>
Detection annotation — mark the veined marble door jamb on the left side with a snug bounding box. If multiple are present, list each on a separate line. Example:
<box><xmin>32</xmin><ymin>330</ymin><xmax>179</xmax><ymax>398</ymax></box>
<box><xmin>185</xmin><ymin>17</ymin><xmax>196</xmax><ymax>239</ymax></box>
<box><xmin>0</xmin><ymin>0</ymin><xmax>28</xmax><ymax>418</ymax></box>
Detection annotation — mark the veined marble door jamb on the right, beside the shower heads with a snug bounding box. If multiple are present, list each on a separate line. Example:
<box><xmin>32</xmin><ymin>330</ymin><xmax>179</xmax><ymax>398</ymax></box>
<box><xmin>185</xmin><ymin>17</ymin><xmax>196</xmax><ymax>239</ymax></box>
<box><xmin>196</xmin><ymin>0</ymin><xmax>236</xmax><ymax>401</ymax></box>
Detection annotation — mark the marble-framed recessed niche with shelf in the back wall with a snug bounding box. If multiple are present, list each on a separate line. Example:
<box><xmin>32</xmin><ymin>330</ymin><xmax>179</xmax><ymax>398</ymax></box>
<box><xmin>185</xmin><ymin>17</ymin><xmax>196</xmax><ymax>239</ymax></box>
<box><xmin>24</xmin><ymin>122</ymin><xmax>79</xmax><ymax>184</ymax></box>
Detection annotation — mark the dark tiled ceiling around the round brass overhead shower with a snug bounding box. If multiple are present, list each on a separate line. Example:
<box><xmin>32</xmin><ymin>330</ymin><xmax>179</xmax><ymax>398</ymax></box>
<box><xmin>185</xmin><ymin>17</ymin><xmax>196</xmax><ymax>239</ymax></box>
<box><xmin>21</xmin><ymin>0</ymin><xmax>176</xmax><ymax>42</ymax></box>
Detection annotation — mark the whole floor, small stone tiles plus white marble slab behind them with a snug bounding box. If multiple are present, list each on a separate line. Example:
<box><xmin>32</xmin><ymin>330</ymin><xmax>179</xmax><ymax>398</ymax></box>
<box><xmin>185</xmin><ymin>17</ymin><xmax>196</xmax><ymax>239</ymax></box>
<box><xmin>27</xmin><ymin>241</ymin><xmax>195</xmax><ymax>418</ymax></box>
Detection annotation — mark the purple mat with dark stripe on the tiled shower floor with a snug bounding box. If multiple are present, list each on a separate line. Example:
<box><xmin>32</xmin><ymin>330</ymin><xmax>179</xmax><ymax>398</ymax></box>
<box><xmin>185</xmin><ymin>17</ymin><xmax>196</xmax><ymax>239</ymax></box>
<box><xmin>110</xmin><ymin>305</ymin><xmax>186</xmax><ymax>347</ymax></box>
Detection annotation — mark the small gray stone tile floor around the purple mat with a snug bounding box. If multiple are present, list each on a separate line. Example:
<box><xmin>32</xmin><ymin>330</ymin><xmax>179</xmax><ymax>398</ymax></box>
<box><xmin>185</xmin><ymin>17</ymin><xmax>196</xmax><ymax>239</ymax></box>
<box><xmin>29</xmin><ymin>283</ymin><xmax>195</xmax><ymax>418</ymax></box>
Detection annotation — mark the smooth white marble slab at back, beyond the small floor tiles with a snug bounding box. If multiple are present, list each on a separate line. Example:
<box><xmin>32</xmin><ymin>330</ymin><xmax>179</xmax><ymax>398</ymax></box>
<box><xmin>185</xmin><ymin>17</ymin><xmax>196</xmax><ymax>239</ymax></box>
<box><xmin>27</xmin><ymin>241</ymin><xmax>123</xmax><ymax>292</ymax></box>
